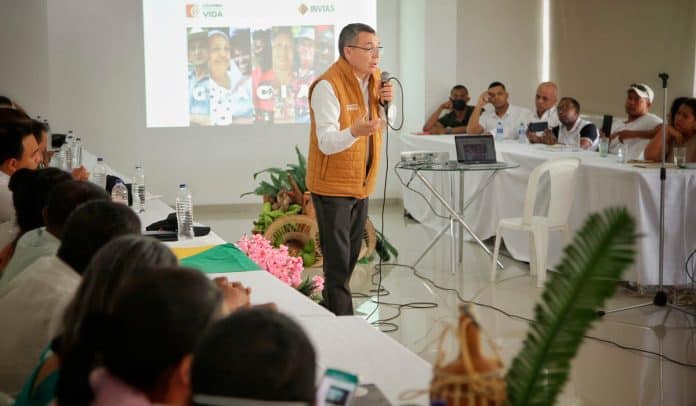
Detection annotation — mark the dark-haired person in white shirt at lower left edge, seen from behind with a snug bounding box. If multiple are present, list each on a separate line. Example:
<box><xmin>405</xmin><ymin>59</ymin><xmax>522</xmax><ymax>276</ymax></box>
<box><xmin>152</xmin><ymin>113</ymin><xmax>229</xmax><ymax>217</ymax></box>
<box><xmin>0</xmin><ymin>198</ymin><xmax>141</xmax><ymax>394</ymax></box>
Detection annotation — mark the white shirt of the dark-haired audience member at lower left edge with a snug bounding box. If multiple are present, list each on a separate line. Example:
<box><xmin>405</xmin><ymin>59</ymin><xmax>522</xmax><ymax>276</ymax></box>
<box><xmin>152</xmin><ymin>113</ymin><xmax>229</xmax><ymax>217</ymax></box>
<box><xmin>0</xmin><ymin>256</ymin><xmax>80</xmax><ymax>394</ymax></box>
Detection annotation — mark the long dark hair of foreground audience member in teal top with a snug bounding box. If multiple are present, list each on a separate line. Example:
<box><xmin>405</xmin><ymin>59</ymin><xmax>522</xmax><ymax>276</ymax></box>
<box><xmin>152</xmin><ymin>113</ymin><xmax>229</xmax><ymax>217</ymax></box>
<box><xmin>55</xmin><ymin>235</ymin><xmax>177</xmax><ymax>404</ymax></box>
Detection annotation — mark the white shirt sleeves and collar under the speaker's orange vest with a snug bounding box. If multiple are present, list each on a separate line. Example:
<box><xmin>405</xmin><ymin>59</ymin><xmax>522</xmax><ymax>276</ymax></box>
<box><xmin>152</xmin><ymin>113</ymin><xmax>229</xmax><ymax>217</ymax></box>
<box><xmin>311</xmin><ymin>77</ymin><xmax>396</xmax><ymax>155</ymax></box>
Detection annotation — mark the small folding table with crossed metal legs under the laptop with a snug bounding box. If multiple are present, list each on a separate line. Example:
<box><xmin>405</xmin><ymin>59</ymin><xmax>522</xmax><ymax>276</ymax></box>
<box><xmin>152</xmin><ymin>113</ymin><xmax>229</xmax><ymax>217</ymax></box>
<box><xmin>395</xmin><ymin>161</ymin><xmax>519</xmax><ymax>273</ymax></box>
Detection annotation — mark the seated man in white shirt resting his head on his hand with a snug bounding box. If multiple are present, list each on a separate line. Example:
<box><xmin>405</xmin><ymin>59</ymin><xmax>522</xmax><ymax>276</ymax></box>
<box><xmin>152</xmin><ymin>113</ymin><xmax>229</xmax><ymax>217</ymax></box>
<box><xmin>466</xmin><ymin>82</ymin><xmax>531</xmax><ymax>140</ymax></box>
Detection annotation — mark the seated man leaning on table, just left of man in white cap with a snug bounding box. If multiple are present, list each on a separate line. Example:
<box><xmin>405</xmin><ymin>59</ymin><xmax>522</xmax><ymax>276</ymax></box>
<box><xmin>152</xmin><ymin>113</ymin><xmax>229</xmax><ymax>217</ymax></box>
<box><xmin>529</xmin><ymin>97</ymin><xmax>599</xmax><ymax>149</ymax></box>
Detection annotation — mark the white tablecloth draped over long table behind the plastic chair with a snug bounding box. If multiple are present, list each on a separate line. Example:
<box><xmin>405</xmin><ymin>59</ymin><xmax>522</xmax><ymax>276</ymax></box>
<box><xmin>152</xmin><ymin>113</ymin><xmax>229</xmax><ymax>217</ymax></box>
<box><xmin>400</xmin><ymin>135</ymin><xmax>696</xmax><ymax>286</ymax></box>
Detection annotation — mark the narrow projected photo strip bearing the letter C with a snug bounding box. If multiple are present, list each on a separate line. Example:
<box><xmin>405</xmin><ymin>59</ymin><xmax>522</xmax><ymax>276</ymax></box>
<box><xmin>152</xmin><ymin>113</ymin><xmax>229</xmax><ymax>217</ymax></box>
<box><xmin>251</xmin><ymin>29</ymin><xmax>273</xmax><ymax>123</ymax></box>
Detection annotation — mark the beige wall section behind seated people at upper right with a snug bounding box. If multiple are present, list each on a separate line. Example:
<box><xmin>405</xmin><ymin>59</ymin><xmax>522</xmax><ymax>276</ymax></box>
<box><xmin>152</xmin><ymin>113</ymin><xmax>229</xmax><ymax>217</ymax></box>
<box><xmin>551</xmin><ymin>0</ymin><xmax>696</xmax><ymax>116</ymax></box>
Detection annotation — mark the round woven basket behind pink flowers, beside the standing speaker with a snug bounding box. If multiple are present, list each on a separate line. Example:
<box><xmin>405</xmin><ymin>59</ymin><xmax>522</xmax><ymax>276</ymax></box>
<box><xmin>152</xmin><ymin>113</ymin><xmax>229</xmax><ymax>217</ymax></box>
<box><xmin>263</xmin><ymin>214</ymin><xmax>323</xmax><ymax>268</ymax></box>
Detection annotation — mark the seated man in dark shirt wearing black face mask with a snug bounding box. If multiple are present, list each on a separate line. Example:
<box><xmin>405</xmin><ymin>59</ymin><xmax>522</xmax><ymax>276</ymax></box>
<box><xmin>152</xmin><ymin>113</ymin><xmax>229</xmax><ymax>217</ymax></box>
<box><xmin>423</xmin><ymin>85</ymin><xmax>474</xmax><ymax>134</ymax></box>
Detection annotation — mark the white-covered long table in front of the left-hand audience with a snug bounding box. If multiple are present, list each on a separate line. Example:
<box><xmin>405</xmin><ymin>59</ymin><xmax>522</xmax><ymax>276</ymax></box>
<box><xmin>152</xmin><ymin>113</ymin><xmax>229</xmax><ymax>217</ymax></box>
<box><xmin>130</xmin><ymin>163</ymin><xmax>432</xmax><ymax>405</ymax></box>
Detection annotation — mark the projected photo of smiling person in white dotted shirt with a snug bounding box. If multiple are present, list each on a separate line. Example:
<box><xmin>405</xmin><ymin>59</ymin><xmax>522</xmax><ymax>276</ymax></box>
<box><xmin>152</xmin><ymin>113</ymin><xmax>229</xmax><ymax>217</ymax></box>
<box><xmin>188</xmin><ymin>27</ymin><xmax>254</xmax><ymax>126</ymax></box>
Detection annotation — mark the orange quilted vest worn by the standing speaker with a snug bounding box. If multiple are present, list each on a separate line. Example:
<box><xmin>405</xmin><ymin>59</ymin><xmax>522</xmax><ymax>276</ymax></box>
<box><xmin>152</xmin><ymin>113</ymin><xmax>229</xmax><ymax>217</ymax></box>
<box><xmin>307</xmin><ymin>57</ymin><xmax>382</xmax><ymax>199</ymax></box>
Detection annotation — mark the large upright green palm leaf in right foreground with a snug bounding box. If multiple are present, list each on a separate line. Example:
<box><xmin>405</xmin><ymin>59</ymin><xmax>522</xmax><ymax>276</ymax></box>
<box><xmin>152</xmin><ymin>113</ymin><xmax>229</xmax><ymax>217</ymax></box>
<box><xmin>506</xmin><ymin>208</ymin><xmax>637</xmax><ymax>405</ymax></box>
